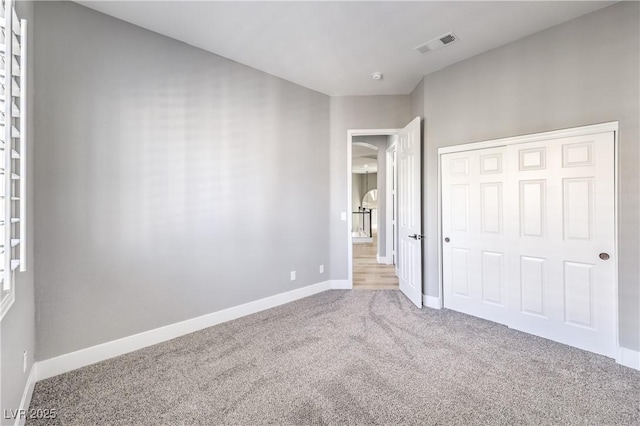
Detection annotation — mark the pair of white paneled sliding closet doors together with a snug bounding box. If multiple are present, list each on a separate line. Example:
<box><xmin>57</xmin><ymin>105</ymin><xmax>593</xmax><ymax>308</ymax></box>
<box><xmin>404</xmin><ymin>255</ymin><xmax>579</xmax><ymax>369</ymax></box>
<box><xmin>441</xmin><ymin>132</ymin><xmax>616</xmax><ymax>357</ymax></box>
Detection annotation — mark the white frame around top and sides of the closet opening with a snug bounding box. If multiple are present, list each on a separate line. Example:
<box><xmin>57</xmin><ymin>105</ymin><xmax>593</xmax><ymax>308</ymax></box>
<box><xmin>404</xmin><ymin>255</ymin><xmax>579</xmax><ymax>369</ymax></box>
<box><xmin>438</xmin><ymin>121</ymin><xmax>622</xmax><ymax>350</ymax></box>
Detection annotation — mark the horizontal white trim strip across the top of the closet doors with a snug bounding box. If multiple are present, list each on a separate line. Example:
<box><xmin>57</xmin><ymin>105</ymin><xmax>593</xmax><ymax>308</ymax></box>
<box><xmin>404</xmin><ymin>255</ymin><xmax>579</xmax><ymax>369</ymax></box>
<box><xmin>438</xmin><ymin>121</ymin><xmax>618</xmax><ymax>156</ymax></box>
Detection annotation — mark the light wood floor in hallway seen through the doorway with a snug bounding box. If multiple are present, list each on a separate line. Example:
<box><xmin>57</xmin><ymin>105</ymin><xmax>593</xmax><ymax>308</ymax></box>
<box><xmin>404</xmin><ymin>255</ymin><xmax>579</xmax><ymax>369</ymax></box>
<box><xmin>353</xmin><ymin>233</ymin><xmax>398</xmax><ymax>290</ymax></box>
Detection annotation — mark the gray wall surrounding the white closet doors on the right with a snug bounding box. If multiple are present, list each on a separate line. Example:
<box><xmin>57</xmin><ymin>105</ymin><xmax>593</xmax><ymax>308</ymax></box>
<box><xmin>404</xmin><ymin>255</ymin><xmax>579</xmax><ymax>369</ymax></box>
<box><xmin>412</xmin><ymin>2</ymin><xmax>640</xmax><ymax>350</ymax></box>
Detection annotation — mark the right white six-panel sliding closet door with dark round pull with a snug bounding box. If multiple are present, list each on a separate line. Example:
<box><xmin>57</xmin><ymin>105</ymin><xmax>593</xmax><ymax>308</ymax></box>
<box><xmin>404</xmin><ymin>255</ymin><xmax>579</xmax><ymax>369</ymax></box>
<box><xmin>506</xmin><ymin>132</ymin><xmax>616</xmax><ymax>357</ymax></box>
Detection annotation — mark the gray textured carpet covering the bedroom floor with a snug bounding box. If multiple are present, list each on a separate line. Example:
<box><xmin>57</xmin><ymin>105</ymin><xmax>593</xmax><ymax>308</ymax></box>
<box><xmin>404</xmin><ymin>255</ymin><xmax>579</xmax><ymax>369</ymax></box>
<box><xmin>27</xmin><ymin>290</ymin><xmax>640</xmax><ymax>425</ymax></box>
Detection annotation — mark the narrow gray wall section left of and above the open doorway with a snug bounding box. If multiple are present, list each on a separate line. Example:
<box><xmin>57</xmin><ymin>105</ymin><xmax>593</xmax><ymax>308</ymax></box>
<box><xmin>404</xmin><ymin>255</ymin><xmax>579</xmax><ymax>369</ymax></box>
<box><xmin>329</xmin><ymin>95</ymin><xmax>411</xmax><ymax>280</ymax></box>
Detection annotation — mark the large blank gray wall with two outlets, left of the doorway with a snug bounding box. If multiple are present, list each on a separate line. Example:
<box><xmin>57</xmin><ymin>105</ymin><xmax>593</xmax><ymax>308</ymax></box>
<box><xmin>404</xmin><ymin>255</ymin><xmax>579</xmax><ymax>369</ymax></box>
<box><xmin>35</xmin><ymin>2</ymin><xmax>332</xmax><ymax>360</ymax></box>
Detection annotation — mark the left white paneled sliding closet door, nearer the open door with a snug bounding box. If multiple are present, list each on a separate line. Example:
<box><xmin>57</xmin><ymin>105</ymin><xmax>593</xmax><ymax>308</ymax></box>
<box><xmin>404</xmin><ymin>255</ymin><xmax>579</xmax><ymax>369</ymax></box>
<box><xmin>442</xmin><ymin>147</ymin><xmax>507</xmax><ymax>324</ymax></box>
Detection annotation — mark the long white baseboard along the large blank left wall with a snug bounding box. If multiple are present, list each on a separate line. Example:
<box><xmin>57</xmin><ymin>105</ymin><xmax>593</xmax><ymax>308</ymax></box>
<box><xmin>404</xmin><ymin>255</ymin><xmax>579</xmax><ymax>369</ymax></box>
<box><xmin>36</xmin><ymin>280</ymin><xmax>332</xmax><ymax>380</ymax></box>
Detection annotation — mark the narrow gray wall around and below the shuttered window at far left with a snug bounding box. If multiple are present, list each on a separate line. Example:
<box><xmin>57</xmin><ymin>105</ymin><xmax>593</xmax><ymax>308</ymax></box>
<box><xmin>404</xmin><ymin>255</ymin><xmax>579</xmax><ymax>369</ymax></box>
<box><xmin>0</xmin><ymin>2</ymin><xmax>36</xmax><ymax>425</ymax></box>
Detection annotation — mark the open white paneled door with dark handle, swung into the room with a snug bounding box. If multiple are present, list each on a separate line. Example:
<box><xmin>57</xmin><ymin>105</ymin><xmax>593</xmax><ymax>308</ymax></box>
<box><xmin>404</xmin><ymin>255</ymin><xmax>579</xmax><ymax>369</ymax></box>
<box><xmin>397</xmin><ymin>117</ymin><xmax>423</xmax><ymax>308</ymax></box>
